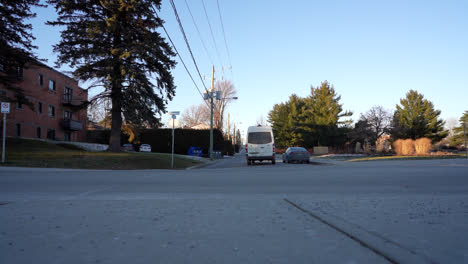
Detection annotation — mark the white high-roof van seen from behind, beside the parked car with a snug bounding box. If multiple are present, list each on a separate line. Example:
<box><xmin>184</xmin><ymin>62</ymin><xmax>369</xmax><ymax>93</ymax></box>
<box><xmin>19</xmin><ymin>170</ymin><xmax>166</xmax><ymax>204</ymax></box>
<box><xmin>245</xmin><ymin>125</ymin><xmax>276</xmax><ymax>165</ymax></box>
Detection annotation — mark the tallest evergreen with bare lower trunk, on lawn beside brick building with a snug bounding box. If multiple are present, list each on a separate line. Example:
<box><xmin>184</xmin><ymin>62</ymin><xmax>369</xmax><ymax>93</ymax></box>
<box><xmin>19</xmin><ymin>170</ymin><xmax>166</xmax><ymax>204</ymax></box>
<box><xmin>48</xmin><ymin>0</ymin><xmax>175</xmax><ymax>151</ymax></box>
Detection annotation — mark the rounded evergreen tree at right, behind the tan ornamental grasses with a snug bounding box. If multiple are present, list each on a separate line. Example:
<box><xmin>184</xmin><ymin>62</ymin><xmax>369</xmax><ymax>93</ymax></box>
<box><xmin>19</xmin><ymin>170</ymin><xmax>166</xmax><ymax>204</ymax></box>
<box><xmin>391</xmin><ymin>90</ymin><xmax>448</xmax><ymax>142</ymax></box>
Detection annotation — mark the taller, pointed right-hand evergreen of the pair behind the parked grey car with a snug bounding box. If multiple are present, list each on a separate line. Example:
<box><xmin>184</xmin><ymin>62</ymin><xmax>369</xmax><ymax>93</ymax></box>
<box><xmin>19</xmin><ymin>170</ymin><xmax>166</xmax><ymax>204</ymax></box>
<box><xmin>298</xmin><ymin>81</ymin><xmax>353</xmax><ymax>147</ymax></box>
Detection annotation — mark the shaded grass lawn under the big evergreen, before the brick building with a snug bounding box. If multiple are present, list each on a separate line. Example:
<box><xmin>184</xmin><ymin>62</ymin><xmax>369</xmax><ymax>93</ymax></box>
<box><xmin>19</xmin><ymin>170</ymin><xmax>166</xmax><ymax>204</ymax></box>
<box><xmin>0</xmin><ymin>138</ymin><xmax>204</xmax><ymax>170</ymax></box>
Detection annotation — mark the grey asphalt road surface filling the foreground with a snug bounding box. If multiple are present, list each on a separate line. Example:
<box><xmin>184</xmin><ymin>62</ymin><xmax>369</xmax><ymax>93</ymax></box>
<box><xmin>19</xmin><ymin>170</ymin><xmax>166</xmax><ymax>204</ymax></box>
<box><xmin>0</xmin><ymin>156</ymin><xmax>468</xmax><ymax>263</ymax></box>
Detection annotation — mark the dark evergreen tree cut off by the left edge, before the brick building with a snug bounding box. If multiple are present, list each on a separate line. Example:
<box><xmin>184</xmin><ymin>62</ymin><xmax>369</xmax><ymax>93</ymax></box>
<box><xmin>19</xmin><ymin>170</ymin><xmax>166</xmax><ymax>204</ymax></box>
<box><xmin>0</xmin><ymin>0</ymin><xmax>43</xmax><ymax>102</ymax></box>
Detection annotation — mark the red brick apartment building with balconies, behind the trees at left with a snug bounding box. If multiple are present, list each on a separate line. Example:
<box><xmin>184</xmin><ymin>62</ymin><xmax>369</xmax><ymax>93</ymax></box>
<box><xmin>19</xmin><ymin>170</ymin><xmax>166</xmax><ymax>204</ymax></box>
<box><xmin>0</xmin><ymin>63</ymin><xmax>88</xmax><ymax>141</ymax></box>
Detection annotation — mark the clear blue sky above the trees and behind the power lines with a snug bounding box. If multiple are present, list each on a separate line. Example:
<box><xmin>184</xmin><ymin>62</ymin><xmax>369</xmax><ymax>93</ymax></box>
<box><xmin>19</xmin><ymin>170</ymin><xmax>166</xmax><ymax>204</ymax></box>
<box><xmin>33</xmin><ymin>0</ymin><xmax>468</xmax><ymax>138</ymax></box>
